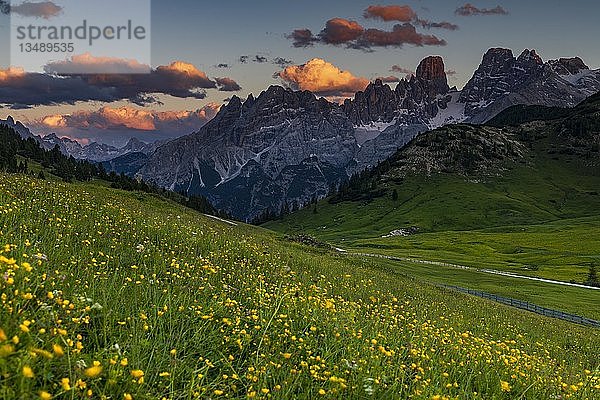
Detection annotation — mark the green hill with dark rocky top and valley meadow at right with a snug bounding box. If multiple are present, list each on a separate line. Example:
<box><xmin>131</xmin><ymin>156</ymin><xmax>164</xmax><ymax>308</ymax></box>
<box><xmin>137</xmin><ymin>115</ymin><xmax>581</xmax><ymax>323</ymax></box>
<box><xmin>264</xmin><ymin>96</ymin><xmax>600</xmax><ymax>312</ymax></box>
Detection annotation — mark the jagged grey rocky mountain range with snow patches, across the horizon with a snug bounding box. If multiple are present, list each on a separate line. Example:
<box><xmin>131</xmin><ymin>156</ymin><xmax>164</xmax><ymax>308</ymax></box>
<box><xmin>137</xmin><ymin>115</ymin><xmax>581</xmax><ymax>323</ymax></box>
<box><xmin>4</xmin><ymin>48</ymin><xmax>600</xmax><ymax>220</ymax></box>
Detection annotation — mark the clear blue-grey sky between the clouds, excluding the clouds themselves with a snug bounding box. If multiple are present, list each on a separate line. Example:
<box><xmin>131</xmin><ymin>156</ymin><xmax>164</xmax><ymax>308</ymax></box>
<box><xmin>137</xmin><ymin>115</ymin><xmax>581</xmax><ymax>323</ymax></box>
<box><xmin>0</xmin><ymin>0</ymin><xmax>600</xmax><ymax>144</ymax></box>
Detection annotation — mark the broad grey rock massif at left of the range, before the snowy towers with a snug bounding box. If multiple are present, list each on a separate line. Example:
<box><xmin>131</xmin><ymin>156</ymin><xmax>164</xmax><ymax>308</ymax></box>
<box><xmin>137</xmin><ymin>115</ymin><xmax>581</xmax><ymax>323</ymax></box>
<box><xmin>140</xmin><ymin>86</ymin><xmax>359</xmax><ymax>219</ymax></box>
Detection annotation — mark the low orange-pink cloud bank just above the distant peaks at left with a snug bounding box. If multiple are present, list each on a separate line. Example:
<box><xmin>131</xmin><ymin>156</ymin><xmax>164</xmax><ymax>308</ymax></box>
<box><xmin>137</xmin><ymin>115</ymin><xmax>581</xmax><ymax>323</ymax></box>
<box><xmin>29</xmin><ymin>103</ymin><xmax>221</xmax><ymax>142</ymax></box>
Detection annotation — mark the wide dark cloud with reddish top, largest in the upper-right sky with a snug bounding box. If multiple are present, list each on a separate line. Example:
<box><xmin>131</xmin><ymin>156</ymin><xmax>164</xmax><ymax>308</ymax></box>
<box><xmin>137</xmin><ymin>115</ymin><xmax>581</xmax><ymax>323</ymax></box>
<box><xmin>288</xmin><ymin>18</ymin><xmax>447</xmax><ymax>51</ymax></box>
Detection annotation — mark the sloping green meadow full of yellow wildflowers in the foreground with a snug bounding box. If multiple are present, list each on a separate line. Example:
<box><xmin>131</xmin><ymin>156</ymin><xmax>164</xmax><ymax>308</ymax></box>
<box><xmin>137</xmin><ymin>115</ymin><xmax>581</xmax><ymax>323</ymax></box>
<box><xmin>0</xmin><ymin>175</ymin><xmax>600</xmax><ymax>399</ymax></box>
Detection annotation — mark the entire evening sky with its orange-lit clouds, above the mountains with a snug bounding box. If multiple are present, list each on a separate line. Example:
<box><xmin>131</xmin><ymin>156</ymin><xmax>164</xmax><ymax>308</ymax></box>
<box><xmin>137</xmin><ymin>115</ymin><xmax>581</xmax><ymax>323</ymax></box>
<box><xmin>0</xmin><ymin>0</ymin><xmax>600</xmax><ymax>145</ymax></box>
